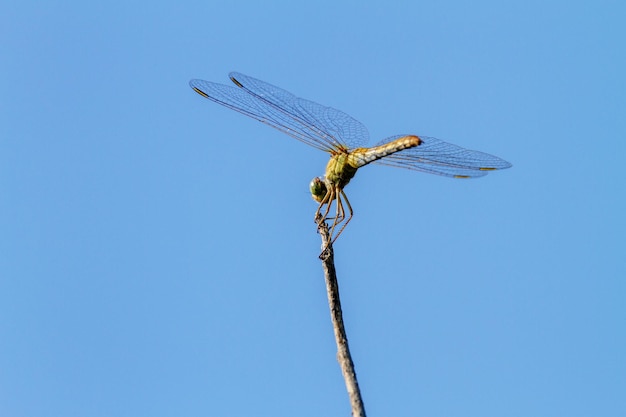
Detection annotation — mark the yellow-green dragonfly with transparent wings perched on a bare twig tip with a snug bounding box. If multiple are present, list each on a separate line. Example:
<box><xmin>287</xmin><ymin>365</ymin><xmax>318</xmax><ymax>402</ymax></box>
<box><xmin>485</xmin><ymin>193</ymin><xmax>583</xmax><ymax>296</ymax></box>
<box><xmin>189</xmin><ymin>72</ymin><xmax>512</xmax><ymax>250</ymax></box>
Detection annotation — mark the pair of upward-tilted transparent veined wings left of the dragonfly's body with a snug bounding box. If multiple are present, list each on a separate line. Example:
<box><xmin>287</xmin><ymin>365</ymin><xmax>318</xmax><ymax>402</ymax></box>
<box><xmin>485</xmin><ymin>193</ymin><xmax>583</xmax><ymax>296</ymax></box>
<box><xmin>189</xmin><ymin>73</ymin><xmax>369</xmax><ymax>151</ymax></box>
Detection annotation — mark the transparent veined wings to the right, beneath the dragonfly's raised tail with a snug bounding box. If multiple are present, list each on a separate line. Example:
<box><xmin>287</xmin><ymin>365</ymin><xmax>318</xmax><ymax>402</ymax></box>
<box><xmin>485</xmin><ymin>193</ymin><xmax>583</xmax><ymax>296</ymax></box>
<box><xmin>373</xmin><ymin>135</ymin><xmax>512</xmax><ymax>178</ymax></box>
